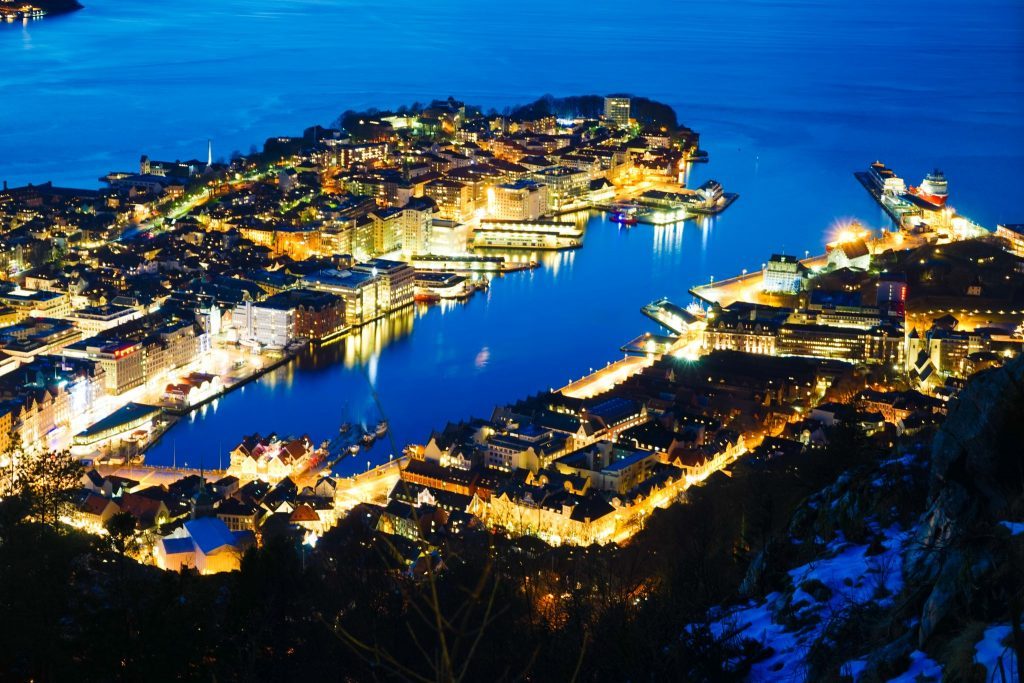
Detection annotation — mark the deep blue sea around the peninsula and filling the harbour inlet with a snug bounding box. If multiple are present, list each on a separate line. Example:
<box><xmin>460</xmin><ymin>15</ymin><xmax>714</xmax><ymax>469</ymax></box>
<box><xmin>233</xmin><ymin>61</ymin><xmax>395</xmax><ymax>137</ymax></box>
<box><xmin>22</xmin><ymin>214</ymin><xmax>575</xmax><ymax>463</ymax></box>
<box><xmin>0</xmin><ymin>0</ymin><xmax>1024</xmax><ymax>467</ymax></box>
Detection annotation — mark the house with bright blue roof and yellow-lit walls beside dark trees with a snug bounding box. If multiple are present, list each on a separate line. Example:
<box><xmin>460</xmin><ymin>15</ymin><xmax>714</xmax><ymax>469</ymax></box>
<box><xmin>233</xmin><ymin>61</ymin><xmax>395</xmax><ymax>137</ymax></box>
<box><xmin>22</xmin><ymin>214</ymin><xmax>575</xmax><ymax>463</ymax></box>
<box><xmin>153</xmin><ymin>517</ymin><xmax>255</xmax><ymax>574</ymax></box>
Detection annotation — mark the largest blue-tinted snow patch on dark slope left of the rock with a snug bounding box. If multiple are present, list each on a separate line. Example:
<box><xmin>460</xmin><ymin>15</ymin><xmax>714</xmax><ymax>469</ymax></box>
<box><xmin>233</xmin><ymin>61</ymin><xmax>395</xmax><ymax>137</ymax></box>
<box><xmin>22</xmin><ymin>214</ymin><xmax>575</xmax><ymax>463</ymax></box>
<box><xmin>712</xmin><ymin>527</ymin><xmax>913</xmax><ymax>681</ymax></box>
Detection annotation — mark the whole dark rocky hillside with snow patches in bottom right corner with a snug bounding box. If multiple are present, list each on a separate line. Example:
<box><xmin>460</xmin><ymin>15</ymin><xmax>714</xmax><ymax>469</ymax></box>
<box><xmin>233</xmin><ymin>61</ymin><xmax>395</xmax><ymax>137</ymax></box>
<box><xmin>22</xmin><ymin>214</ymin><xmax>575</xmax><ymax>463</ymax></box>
<box><xmin>712</xmin><ymin>356</ymin><xmax>1024</xmax><ymax>681</ymax></box>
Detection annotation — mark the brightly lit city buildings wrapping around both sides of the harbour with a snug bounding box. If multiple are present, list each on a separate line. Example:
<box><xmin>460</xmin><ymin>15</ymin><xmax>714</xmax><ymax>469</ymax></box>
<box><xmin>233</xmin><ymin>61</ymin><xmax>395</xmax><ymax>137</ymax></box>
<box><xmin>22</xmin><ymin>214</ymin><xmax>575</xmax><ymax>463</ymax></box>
<box><xmin>0</xmin><ymin>96</ymin><xmax>1024</xmax><ymax>573</ymax></box>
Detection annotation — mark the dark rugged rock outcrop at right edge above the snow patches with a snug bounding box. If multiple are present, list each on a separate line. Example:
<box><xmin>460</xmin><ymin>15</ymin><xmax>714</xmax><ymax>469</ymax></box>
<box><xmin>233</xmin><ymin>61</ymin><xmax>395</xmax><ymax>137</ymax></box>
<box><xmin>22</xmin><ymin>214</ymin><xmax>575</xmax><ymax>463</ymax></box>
<box><xmin>904</xmin><ymin>357</ymin><xmax>1024</xmax><ymax>646</ymax></box>
